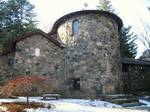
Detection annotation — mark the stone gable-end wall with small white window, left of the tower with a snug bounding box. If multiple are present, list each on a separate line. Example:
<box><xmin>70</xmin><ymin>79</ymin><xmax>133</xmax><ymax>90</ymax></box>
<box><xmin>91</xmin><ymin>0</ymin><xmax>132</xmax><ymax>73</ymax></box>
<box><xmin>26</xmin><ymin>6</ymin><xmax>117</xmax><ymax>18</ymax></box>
<box><xmin>14</xmin><ymin>34</ymin><xmax>64</xmax><ymax>89</ymax></box>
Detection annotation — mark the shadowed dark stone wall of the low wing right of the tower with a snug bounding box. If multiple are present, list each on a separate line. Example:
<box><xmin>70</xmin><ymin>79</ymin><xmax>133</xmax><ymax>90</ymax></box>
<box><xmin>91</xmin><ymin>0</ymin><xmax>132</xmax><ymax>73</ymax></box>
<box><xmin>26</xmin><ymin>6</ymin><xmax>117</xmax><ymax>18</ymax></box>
<box><xmin>122</xmin><ymin>64</ymin><xmax>150</xmax><ymax>94</ymax></box>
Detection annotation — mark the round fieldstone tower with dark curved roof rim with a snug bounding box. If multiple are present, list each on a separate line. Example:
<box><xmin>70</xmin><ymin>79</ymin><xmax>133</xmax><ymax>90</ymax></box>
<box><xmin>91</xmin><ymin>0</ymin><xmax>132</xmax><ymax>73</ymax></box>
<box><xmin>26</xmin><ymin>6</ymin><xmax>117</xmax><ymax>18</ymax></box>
<box><xmin>50</xmin><ymin>10</ymin><xmax>123</xmax><ymax>97</ymax></box>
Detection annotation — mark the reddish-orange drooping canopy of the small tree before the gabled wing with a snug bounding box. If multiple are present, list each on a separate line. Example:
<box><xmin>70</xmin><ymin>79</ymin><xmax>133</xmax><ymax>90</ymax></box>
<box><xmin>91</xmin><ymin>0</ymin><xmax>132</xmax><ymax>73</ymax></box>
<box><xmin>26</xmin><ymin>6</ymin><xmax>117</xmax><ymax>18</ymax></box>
<box><xmin>2</xmin><ymin>76</ymin><xmax>56</xmax><ymax>98</ymax></box>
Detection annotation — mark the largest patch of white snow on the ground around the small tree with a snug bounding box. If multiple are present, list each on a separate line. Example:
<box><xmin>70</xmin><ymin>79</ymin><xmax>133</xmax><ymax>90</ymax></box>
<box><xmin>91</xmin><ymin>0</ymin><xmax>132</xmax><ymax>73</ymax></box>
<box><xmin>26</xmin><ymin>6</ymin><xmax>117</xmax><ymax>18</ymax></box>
<box><xmin>0</xmin><ymin>97</ymin><xmax>148</xmax><ymax>112</ymax></box>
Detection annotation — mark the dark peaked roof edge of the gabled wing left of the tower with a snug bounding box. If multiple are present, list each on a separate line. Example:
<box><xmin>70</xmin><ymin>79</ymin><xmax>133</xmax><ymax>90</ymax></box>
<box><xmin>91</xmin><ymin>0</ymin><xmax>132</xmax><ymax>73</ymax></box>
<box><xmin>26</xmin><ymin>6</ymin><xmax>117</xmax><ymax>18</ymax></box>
<box><xmin>11</xmin><ymin>29</ymin><xmax>64</xmax><ymax>50</ymax></box>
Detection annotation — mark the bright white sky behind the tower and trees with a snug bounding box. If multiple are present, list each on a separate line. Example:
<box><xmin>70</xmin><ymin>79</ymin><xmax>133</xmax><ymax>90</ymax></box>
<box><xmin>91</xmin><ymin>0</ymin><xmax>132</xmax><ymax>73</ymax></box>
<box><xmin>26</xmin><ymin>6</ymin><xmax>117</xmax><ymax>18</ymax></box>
<box><xmin>30</xmin><ymin>0</ymin><xmax>150</xmax><ymax>56</ymax></box>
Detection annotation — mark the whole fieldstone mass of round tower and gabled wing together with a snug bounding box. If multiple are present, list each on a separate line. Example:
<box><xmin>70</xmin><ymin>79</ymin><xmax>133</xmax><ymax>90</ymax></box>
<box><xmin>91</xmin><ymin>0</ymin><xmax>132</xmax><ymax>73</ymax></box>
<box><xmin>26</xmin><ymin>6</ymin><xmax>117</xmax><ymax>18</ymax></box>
<box><xmin>0</xmin><ymin>10</ymin><xmax>122</xmax><ymax>97</ymax></box>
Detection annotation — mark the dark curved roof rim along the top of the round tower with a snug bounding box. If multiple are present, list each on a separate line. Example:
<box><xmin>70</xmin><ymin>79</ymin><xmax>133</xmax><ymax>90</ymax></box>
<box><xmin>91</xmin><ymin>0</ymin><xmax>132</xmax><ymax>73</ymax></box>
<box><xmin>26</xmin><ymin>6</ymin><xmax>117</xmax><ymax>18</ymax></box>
<box><xmin>48</xmin><ymin>10</ymin><xmax>123</xmax><ymax>35</ymax></box>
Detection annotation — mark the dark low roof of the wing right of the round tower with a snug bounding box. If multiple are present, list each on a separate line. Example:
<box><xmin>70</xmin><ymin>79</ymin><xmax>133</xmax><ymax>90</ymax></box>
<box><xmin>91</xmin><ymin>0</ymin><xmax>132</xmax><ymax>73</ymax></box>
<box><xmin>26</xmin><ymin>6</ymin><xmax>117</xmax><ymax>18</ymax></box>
<box><xmin>121</xmin><ymin>58</ymin><xmax>150</xmax><ymax>66</ymax></box>
